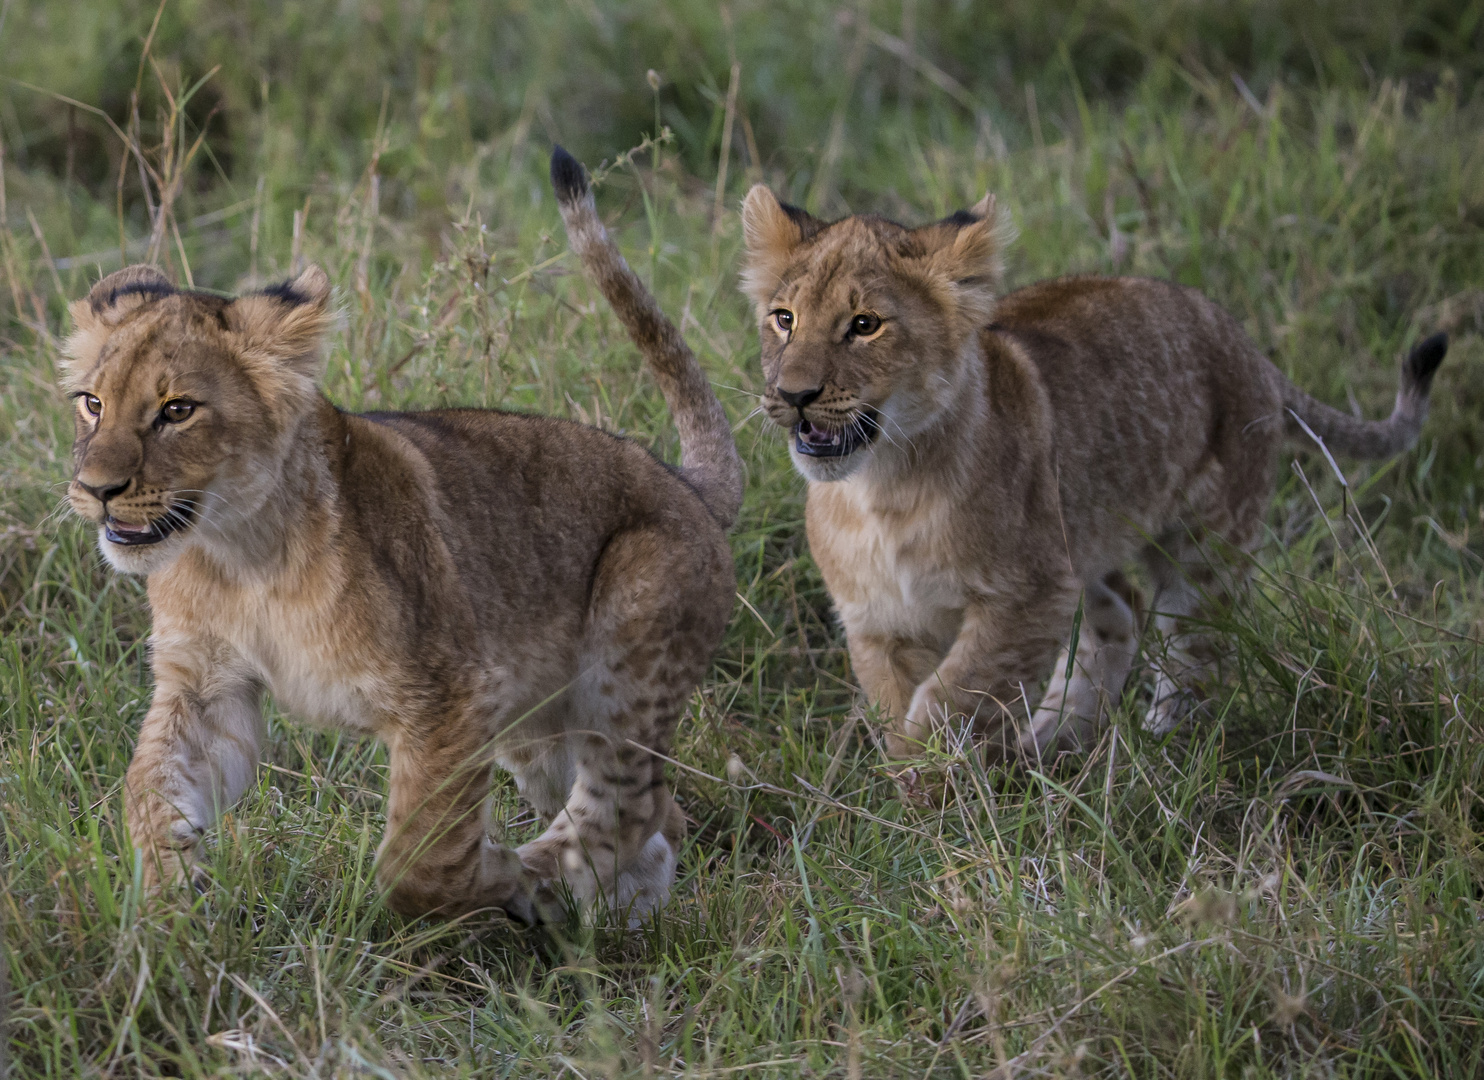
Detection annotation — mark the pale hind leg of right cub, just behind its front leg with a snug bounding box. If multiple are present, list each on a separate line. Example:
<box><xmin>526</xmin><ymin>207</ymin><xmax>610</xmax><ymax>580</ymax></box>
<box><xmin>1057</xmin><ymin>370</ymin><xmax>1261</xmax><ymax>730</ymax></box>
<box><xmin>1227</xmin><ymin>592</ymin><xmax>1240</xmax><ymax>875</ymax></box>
<box><xmin>1020</xmin><ymin>571</ymin><xmax>1138</xmax><ymax>758</ymax></box>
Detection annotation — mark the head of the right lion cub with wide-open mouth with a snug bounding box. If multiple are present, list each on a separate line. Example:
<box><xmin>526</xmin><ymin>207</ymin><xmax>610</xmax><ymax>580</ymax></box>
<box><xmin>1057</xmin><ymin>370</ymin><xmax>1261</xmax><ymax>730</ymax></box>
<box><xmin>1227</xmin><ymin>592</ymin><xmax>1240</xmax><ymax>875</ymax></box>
<box><xmin>742</xmin><ymin>184</ymin><xmax>1009</xmax><ymax>481</ymax></box>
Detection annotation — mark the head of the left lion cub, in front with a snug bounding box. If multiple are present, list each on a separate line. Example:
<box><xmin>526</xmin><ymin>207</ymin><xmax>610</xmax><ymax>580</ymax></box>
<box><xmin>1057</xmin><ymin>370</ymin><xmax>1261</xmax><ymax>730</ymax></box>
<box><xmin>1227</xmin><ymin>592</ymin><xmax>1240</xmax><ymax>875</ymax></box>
<box><xmin>62</xmin><ymin>266</ymin><xmax>331</xmax><ymax>573</ymax></box>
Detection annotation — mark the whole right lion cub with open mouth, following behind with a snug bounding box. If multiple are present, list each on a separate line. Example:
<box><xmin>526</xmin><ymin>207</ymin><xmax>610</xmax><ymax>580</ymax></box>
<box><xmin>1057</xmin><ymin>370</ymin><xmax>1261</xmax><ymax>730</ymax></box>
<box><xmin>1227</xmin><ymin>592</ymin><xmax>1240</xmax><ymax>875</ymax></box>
<box><xmin>742</xmin><ymin>185</ymin><xmax>1447</xmax><ymax>757</ymax></box>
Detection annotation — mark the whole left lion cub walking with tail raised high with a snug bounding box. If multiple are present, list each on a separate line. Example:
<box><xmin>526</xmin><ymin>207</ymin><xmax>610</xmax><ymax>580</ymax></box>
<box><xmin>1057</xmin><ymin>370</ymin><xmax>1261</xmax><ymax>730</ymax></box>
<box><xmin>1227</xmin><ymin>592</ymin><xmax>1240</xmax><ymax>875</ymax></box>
<box><xmin>67</xmin><ymin>148</ymin><xmax>742</xmax><ymax>920</ymax></box>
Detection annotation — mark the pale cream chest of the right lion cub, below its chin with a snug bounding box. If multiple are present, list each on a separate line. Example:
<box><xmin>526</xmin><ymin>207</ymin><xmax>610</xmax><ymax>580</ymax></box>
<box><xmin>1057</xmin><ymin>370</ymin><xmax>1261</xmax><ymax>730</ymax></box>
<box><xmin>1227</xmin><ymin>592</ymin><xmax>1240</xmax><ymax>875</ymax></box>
<box><xmin>807</xmin><ymin>481</ymin><xmax>969</xmax><ymax>651</ymax></box>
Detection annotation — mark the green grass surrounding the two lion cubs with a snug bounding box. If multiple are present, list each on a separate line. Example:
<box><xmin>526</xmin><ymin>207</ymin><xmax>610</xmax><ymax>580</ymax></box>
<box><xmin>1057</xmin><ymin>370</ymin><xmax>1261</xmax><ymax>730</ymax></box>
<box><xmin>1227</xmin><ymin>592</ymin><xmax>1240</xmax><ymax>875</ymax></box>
<box><xmin>0</xmin><ymin>4</ymin><xmax>1484</xmax><ymax>1077</ymax></box>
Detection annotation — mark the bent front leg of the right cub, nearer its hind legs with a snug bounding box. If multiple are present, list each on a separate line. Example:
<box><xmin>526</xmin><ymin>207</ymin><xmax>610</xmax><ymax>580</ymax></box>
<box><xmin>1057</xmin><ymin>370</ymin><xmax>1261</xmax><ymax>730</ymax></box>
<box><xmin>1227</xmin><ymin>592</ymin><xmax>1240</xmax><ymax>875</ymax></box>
<box><xmin>892</xmin><ymin>583</ymin><xmax>1079</xmax><ymax>754</ymax></box>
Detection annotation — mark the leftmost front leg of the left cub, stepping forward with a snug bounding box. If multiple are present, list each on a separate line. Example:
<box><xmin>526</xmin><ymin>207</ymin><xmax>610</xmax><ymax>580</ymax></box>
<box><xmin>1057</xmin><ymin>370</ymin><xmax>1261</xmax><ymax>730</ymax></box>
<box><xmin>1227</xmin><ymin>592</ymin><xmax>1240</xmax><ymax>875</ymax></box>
<box><xmin>125</xmin><ymin>641</ymin><xmax>263</xmax><ymax>890</ymax></box>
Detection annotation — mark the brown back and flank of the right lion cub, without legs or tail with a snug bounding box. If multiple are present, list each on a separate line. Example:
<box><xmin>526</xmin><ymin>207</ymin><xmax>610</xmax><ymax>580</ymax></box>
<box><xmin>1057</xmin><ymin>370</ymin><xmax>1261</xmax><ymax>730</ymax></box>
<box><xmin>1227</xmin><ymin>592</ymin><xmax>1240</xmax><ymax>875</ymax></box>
<box><xmin>982</xmin><ymin>277</ymin><xmax>1284</xmax><ymax>561</ymax></box>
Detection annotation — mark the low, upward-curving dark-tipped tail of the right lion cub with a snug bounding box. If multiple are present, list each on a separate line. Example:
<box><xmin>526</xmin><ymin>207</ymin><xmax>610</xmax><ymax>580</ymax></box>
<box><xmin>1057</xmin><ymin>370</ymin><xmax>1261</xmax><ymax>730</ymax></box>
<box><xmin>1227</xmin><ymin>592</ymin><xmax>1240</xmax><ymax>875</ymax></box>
<box><xmin>1282</xmin><ymin>334</ymin><xmax>1448</xmax><ymax>458</ymax></box>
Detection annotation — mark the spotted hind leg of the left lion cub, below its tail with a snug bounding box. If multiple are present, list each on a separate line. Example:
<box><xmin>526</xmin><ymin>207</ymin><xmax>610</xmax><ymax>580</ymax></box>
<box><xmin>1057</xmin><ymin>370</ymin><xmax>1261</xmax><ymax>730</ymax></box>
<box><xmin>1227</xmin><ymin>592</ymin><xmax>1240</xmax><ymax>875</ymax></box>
<box><xmin>519</xmin><ymin>528</ymin><xmax>733</xmax><ymax>923</ymax></box>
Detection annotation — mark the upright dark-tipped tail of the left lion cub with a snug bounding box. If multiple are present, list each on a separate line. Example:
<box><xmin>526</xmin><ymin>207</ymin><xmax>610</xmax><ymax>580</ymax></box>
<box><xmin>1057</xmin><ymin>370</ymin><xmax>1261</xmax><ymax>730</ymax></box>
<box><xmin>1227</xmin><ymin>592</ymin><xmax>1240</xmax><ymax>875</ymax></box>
<box><xmin>552</xmin><ymin>147</ymin><xmax>742</xmax><ymax>528</ymax></box>
